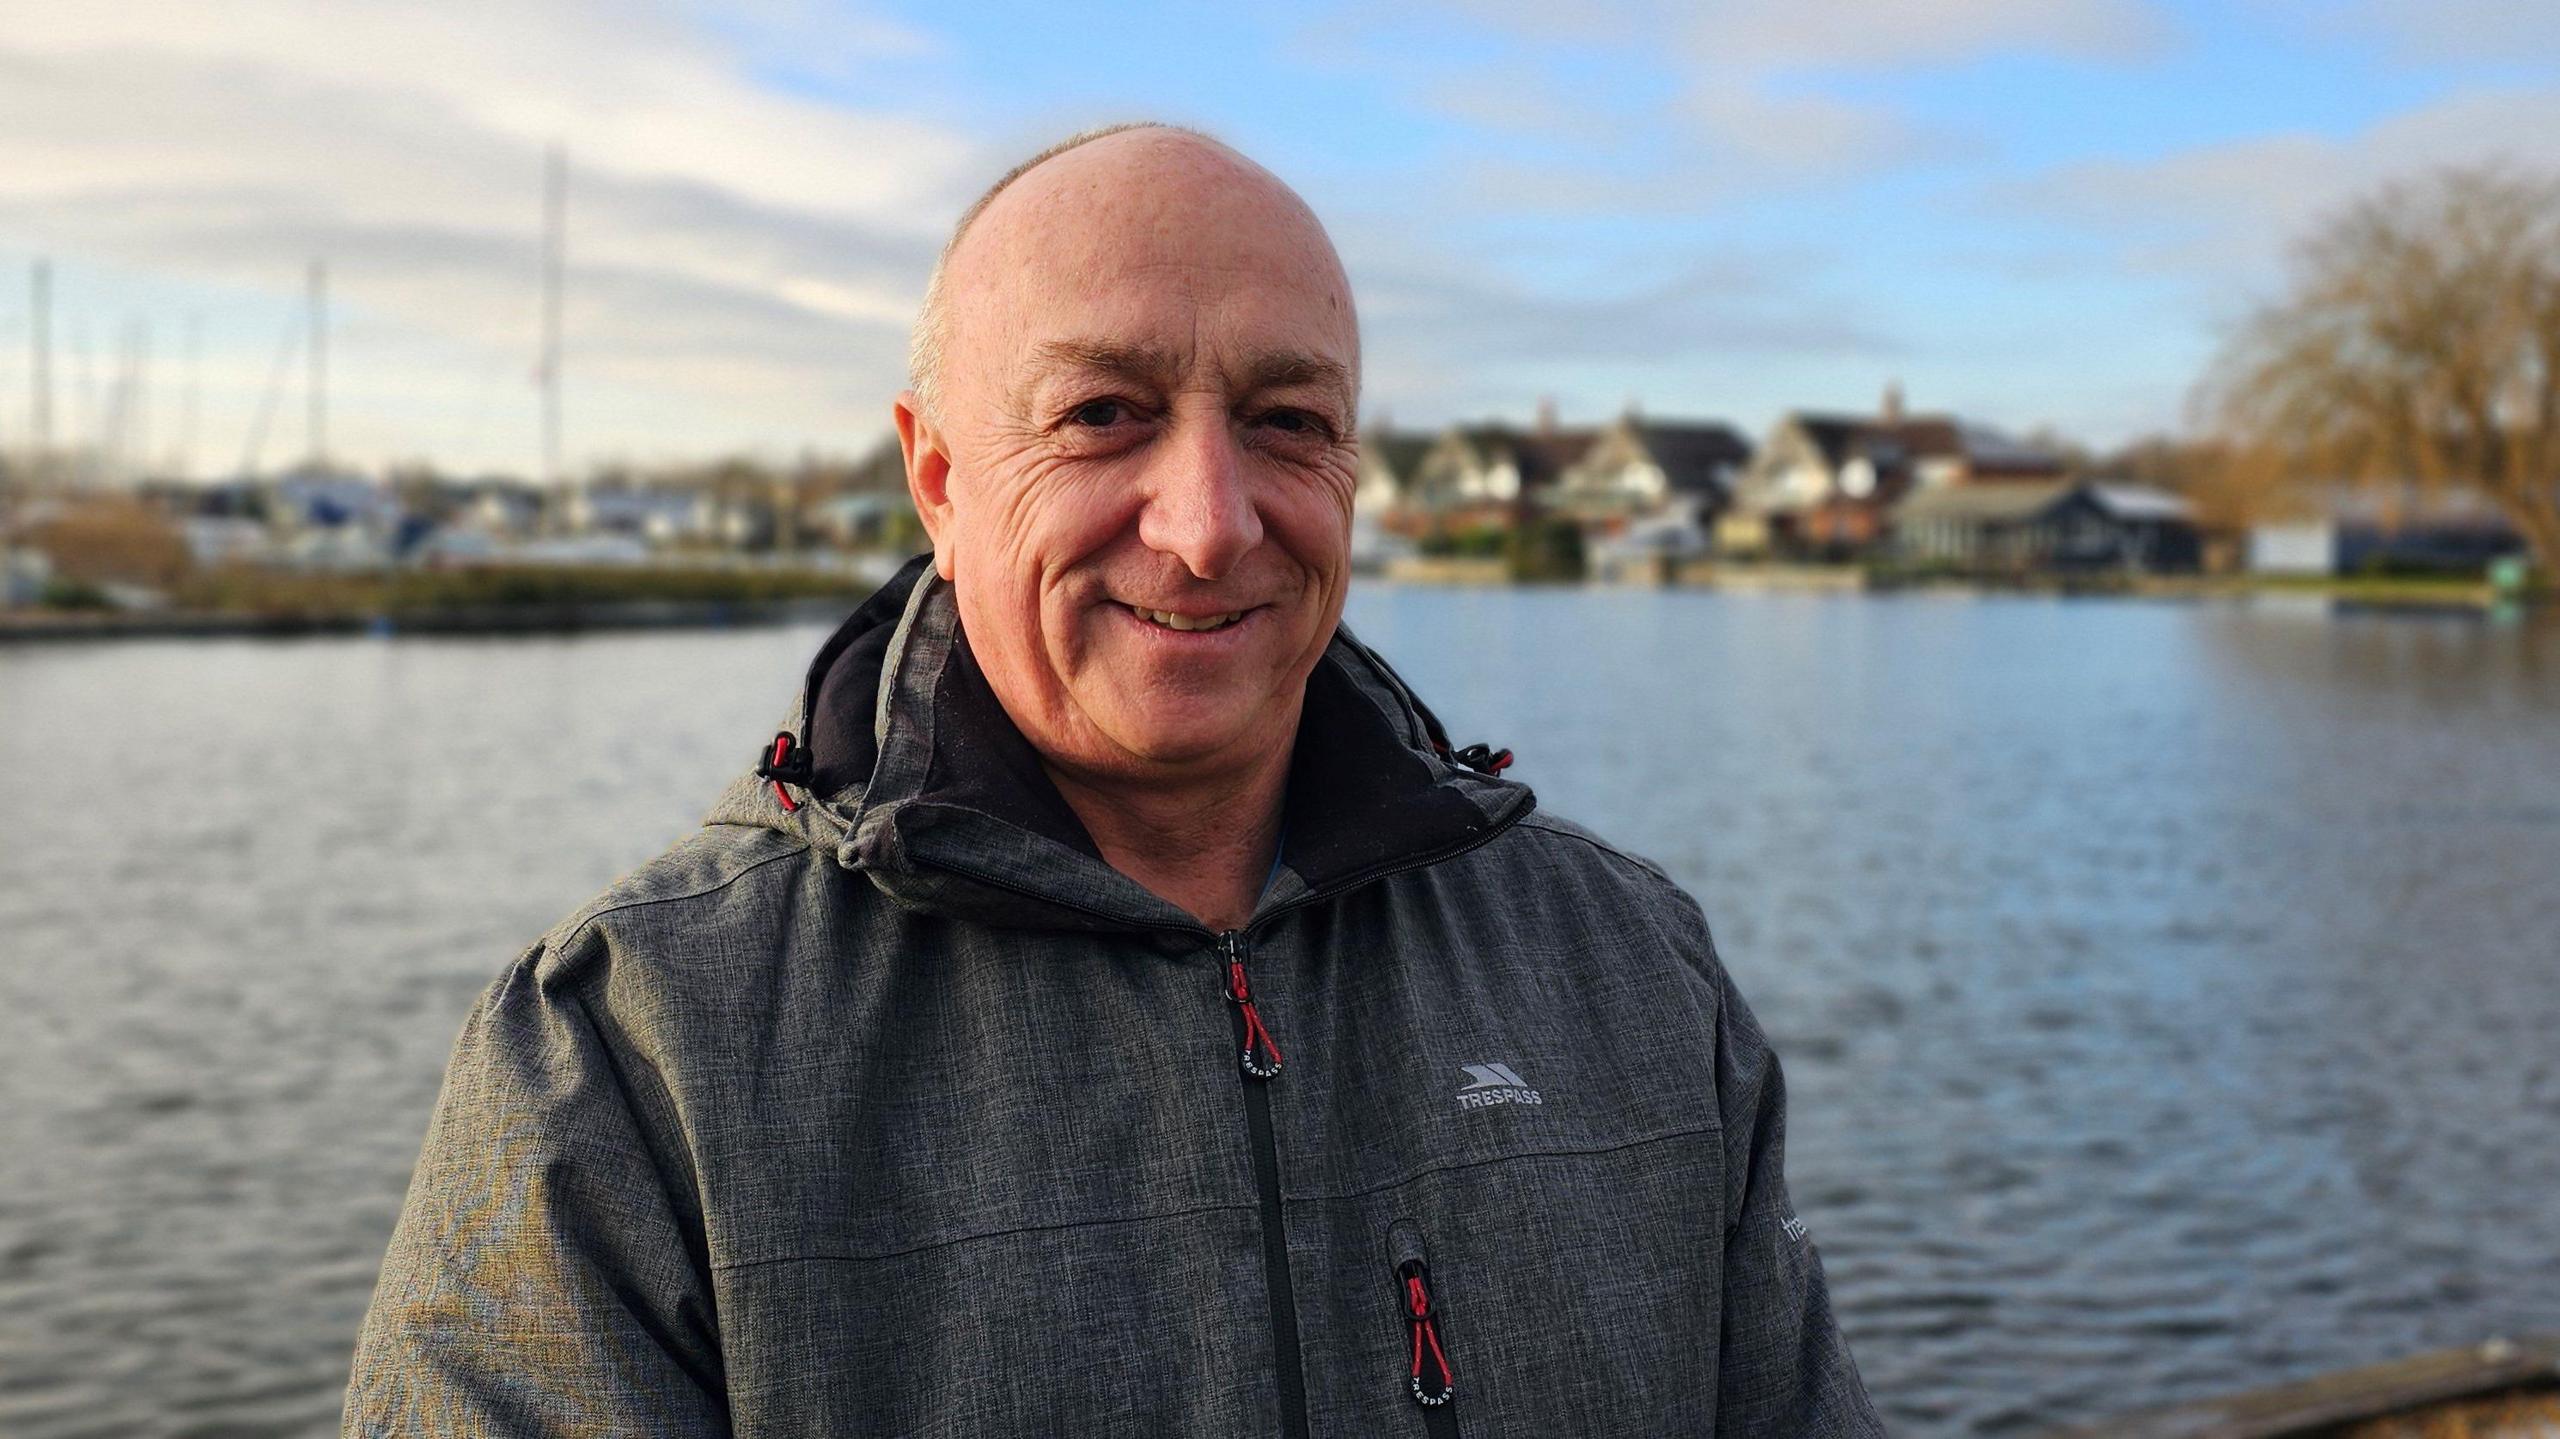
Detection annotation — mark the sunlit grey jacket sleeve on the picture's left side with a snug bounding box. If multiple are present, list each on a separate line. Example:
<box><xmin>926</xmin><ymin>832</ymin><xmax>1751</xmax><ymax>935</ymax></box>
<box><xmin>343</xmin><ymin>950</ymin><xmax>730</xmax><ymax>1436</ymax></box>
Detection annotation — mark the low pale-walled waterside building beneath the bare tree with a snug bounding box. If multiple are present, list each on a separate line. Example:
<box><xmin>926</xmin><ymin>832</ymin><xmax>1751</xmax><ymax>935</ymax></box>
<box><xmin>2248</xmin><ymin>484</ymin><xmax>2524</xmax><ymax>576</ymax></box>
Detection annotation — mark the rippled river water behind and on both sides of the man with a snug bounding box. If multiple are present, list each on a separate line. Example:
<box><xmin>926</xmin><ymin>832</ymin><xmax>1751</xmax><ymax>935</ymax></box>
<box><xmin>0</xmin><ymin>589</ymin><xmax>2560</xmax><ymax>1439</ymax></box>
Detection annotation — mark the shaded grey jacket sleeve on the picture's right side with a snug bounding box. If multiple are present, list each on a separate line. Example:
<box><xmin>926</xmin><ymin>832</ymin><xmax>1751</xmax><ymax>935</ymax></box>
<box><xmin>1715</xmin><ymin>947</ymin><xmax>1884</xmax><ymax>1439</ymax></box>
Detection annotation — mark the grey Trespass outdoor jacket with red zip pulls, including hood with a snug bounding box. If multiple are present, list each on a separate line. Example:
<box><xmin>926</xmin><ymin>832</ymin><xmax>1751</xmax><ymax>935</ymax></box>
<box><xmin>346</xmin><ymin>555</ymin><xmax>1882</xmax><ymax>1439</ymax></box>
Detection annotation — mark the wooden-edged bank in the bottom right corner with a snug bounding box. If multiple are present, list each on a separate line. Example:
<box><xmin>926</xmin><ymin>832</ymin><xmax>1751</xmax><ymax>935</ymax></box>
<box><xmin>2048</xmin><ymin>1334</ymin><xmax>2560</xmax><ymax>1439</ymax></box>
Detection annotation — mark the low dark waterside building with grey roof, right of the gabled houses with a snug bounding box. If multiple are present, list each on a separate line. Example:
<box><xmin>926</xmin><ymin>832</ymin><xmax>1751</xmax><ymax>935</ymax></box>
<box><xmin>1892</xmin><ymin>479</ymin><xmax>2202</xmax><ymax>574</ymax></box>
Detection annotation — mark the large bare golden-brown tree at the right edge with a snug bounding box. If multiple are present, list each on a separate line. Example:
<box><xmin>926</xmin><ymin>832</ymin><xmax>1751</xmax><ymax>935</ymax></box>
<box><xmin>2204</xmin><ymin>166</ymin><xmax>2560</xmax><ymax>574</ymax></box>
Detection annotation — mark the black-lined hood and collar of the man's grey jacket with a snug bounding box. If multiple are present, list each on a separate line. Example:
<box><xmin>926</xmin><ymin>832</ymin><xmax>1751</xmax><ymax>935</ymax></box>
<box><xmin>707</xmin><ymin>556</ymin><xmax>1536</xmax><ymax>945</ymax></box>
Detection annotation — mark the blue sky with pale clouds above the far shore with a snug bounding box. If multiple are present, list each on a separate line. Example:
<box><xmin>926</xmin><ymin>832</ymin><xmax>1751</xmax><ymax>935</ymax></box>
<box><xmin>0</xmin><ymin>0</ymin><xmax>2560</xmax><ymax>476</ymax></box>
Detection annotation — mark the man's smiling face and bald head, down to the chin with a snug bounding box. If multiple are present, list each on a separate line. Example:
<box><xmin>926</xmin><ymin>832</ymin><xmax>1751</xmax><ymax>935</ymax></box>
<box><xmin>899</xmin><ymin>131</ymin><xmax>1359</xmax><ymax>781</ymax></box>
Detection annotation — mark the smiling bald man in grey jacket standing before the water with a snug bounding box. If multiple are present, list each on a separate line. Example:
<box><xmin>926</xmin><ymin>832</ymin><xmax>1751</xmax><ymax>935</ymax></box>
<box><xmin>346</xmin><ymin>125</ymin><xmax>1882</xmax><ymax>1439</ymax></box>
